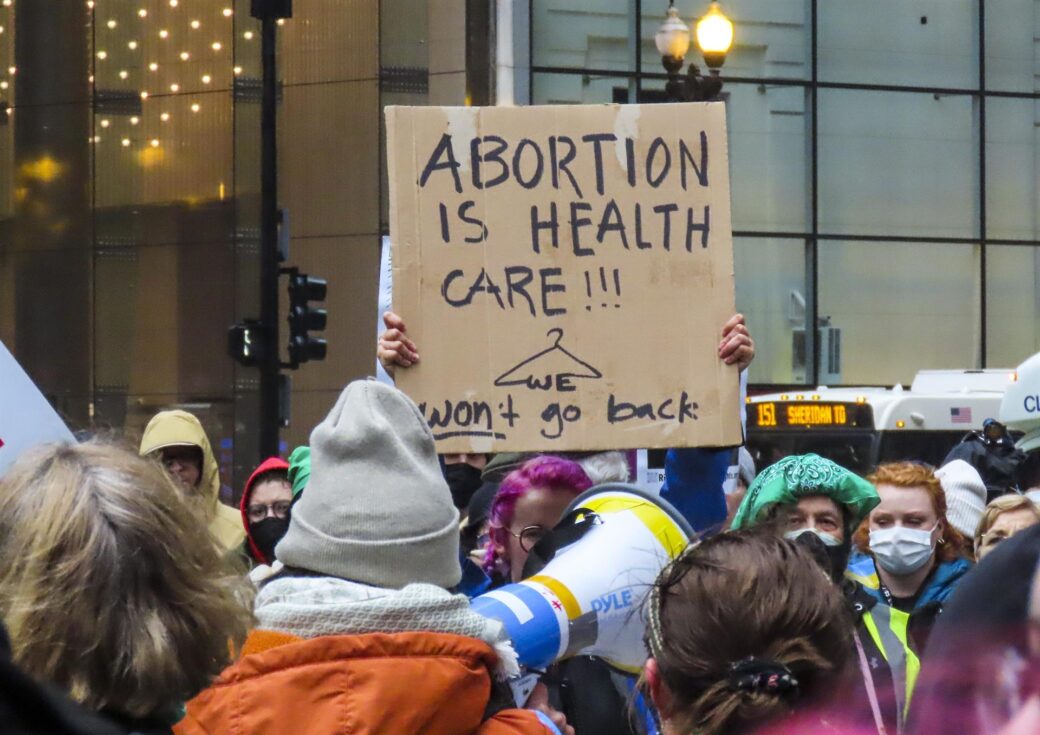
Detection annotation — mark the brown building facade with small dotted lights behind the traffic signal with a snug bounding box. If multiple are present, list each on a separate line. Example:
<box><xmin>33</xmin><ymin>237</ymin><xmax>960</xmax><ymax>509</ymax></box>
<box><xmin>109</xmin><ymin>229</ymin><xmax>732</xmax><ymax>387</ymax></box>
<box><xmin>0</xmin><ymin>0</ymin><xmax>467</xmax><ymax>498</ymax></box>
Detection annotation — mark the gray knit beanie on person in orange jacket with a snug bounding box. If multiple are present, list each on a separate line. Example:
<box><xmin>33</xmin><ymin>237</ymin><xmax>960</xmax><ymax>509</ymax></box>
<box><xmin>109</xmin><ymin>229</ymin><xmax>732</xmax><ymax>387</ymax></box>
<box><xmin>275</xmin><ymin>380</ymin><xmax>462</xmax><ymax>589</ymax></box>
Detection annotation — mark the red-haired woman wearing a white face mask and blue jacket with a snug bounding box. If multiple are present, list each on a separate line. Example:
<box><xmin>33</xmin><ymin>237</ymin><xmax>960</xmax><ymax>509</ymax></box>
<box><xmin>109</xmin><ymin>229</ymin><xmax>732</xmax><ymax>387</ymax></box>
<box><xmin>850</xmin><ymin>462</ymin><xmax>971</xmax><ymax>638</ymax></box>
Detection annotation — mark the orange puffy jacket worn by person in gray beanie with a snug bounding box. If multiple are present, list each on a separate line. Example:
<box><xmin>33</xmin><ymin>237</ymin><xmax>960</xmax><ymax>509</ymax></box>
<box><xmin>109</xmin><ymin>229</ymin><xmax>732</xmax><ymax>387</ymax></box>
<box><xmin>174</xmin><ymin>630</ymin><xmax>549</xmax><ymax>735</ymax></box>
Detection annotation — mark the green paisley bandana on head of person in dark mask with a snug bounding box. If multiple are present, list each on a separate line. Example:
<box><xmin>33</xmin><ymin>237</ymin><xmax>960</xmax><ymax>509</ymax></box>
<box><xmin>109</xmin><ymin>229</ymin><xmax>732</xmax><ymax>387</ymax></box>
<box><xmin>730</xmin><ymin>454</ymin><xmax>881</xmax><ymax>532</ymax></box>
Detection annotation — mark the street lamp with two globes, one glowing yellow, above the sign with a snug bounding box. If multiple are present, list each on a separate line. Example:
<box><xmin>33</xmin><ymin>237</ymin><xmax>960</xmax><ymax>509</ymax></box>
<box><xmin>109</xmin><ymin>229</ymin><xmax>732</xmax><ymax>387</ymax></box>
<box><xmin>654</xmin><ymin>2</ymin><xmax>733</xmax><ymax>102</ymax></box>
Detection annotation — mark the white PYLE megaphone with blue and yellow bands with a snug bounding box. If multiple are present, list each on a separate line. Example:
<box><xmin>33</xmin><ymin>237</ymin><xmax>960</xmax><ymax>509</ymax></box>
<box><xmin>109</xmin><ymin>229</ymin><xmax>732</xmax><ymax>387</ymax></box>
<box><xmin>471</xmin><ymin>483</ymin><xmax>694</xmax><ymax>674</ymax></box>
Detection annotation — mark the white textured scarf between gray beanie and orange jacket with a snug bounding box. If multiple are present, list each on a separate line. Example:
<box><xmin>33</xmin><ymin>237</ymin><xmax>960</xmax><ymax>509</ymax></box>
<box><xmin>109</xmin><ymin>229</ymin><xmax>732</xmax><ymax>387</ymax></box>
<box><xmin>256</xmin><ymin>577</ymin><xmax>520</xmax><ymax>680</ymax></box>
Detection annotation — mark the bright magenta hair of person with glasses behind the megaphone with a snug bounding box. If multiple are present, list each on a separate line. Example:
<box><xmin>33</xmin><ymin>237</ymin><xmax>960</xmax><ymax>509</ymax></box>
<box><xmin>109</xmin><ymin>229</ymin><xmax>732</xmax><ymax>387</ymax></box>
<box><xmin>484</xmin><ymin>454</ymin><xmax>592</xmax><ymax>573</ymax></box>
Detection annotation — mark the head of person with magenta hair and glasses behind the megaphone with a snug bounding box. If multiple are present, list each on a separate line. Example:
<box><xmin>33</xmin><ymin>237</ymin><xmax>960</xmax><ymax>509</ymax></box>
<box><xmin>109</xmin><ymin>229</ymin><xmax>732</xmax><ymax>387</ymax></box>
<box><xmin>484</xmin><ymin>455</ymin><xmax>592</xmax><ymax>582</ymax></box>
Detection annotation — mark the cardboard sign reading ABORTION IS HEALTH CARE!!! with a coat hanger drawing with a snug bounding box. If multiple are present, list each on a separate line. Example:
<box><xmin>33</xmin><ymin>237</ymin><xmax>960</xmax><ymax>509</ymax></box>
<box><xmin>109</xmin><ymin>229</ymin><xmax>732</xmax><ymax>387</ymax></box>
<box><xmin>386</xmin><ymin>103</ymin><xmax>740</xmax><ymax>452</ymax></box>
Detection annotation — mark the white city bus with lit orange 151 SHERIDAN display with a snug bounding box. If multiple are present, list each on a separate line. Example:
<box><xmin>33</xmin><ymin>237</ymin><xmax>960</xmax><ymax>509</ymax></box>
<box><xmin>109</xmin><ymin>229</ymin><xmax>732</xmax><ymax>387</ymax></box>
<box><xmin>746</xmin><ymin>369</ymin><xmax>1014</xmax><ymax>474</ymax></box>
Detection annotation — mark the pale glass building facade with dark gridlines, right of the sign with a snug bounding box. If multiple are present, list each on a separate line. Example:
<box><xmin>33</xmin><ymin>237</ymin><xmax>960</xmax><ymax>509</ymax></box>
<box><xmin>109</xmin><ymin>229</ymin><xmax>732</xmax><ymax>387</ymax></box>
<box><xmin>529</xmin><ymin>0</ymin><xmax>1040</xmax><ymax>385</ymax></box>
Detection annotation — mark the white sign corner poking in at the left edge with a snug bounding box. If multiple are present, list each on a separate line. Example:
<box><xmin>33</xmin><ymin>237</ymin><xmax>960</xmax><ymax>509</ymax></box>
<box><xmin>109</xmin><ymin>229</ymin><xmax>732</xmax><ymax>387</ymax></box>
<box><xmin>0</xmin><ymin>343</ymin><xmax>76</xmax><ymax>477</ymax></box>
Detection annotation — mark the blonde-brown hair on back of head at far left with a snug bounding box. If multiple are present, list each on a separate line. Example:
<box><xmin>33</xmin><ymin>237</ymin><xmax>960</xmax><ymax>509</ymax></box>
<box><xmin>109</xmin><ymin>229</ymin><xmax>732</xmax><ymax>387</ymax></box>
<box><xmin>0</xmin><ymin>442</ymin><xmax>253</xmax><ymax>717</ymax></box>
